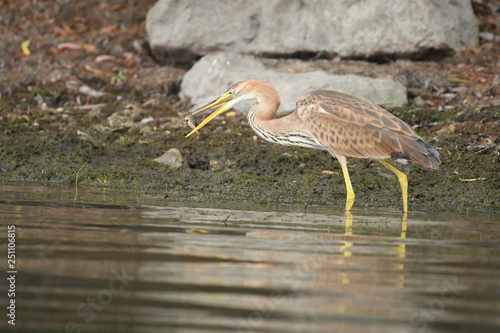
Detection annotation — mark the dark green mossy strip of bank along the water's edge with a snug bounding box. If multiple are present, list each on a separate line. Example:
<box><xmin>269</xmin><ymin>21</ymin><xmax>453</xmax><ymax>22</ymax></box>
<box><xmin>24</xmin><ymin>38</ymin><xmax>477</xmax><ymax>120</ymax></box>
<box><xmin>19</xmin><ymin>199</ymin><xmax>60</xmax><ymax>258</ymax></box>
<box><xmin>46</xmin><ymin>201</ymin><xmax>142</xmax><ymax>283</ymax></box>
<box><xmin>0</xmin><ymin>101</ymin><xmax>500</xmax><ymax>211</ymax></box>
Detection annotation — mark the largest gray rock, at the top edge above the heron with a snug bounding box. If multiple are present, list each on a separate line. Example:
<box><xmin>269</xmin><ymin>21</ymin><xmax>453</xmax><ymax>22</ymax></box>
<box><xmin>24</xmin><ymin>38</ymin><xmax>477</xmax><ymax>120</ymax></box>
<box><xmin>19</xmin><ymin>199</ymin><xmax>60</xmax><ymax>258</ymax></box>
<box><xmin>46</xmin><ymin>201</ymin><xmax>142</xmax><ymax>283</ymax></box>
<box><xmin>146</xmin><ymin>0</ymin><xmax>478</xmax><ymax>59</ymax></box>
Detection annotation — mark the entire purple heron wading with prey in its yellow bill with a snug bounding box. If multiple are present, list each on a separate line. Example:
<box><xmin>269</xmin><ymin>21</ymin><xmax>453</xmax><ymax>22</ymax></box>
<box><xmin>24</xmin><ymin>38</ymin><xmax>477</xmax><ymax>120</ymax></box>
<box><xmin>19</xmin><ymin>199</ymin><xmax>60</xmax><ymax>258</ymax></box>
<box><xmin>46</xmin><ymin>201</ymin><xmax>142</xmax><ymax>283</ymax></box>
<box><xmin>186</xmin><ymin>80</ymin><xmax>441</xmax><ymax>213</ymax></box>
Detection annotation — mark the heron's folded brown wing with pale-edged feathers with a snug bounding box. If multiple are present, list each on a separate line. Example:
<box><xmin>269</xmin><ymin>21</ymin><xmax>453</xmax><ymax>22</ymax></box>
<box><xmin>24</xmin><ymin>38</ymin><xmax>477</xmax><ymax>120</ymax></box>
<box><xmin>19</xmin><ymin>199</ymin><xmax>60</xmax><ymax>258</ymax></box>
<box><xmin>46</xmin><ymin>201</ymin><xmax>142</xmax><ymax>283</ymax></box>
<box><xmin>297</xmin><ymin>91</ymin><xmax>439</xmax><ymax>168</ymax></box>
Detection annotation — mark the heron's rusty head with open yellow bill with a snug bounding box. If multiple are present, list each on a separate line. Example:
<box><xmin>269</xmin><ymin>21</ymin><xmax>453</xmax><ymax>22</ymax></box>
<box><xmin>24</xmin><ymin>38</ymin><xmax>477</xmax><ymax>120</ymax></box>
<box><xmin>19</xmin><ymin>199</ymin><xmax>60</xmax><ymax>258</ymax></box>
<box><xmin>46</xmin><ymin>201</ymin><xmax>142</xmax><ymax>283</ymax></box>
<box><xmin>186</xmin><ymin>80</ymin><xmax>263</xmax><ymax>138</ymax></box>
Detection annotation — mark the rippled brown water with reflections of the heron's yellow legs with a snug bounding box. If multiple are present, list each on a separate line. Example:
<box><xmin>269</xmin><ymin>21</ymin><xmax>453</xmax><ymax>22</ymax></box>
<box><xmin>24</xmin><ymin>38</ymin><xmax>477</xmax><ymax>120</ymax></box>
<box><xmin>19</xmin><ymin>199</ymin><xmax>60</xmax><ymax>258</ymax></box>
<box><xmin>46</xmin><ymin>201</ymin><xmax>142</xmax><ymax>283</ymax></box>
<box><xmin>0</xmin><ymin>185</ymin><xmax>500</xmax><ymax>332</ymax></box>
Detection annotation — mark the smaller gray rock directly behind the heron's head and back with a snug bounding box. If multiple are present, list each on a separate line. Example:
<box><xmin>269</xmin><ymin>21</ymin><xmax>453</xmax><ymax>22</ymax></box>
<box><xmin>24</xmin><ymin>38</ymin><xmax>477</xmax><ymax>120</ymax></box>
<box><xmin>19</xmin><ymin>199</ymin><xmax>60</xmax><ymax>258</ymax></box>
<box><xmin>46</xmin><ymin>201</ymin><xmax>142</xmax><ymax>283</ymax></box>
<box><xmin>180</xmin><ymin>52</ymin><xmax>407</xmax><ymax>113</ymax></box>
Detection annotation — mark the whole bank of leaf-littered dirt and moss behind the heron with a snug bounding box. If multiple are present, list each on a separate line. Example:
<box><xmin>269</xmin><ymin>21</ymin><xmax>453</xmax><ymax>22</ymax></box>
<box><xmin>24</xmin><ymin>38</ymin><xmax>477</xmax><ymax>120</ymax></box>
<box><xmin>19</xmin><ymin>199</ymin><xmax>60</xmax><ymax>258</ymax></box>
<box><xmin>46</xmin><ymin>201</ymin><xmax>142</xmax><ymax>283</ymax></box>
<box><xmin>0</xmin><ymin>0</ymin><xmax>500</xmax><ymax>212</ymax></box>
